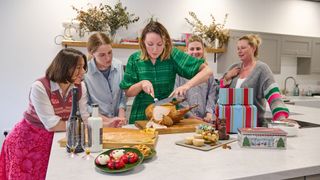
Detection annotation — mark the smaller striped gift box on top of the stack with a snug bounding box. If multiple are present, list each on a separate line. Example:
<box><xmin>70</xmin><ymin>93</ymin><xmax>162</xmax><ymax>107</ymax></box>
<box><xmin>219</xmin><ymin>88</ymin><xmax>253</xmax><ymax>105</ymax></box>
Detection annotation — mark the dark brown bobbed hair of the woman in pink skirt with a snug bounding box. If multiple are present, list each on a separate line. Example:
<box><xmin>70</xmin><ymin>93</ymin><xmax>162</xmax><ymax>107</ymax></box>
<box><xmin>46</xmin><ymin>48</ymin><xmax>87</xmax><ymax>83</ymax></box>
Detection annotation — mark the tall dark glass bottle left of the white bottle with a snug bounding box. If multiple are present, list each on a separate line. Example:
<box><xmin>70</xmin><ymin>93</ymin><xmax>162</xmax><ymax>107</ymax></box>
<box><xmin>66</xmin><ymin>87</ymin><xmax>84</xmax><ymax>153</ymax></box>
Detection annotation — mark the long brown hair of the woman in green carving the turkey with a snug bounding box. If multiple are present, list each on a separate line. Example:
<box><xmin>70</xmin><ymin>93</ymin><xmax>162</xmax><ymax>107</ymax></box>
<box><xmin>139</xmin><ymin>20</ymin><xmax>172</xmax><ymax>60</ymax></box>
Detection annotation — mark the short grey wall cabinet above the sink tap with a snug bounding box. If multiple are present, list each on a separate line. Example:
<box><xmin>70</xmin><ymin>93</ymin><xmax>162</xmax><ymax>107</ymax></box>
<box><xmin>281</xmin><ymin>35</ymin><xmax>312</xmax><ymax>57</ymax></box>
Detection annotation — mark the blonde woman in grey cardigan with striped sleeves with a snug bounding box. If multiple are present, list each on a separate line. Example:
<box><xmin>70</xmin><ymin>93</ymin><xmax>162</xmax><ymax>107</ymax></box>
<box><xmin>220</xmin><ymin>34</ymin><xmax>289</xmax><ymax>126</ymax></box>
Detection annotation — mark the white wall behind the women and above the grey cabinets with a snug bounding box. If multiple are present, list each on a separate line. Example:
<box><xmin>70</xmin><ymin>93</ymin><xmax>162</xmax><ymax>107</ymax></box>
<box><xmin>0</xmin><ymin>0</ymin><xmax>320</xmax><ymax>132</ymax></box>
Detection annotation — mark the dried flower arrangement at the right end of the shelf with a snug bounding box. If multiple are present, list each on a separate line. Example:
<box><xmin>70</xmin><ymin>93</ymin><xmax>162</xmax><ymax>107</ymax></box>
<box><xmin>185</xmin><ymin>12</ymin><xmax>230</xmax><ymax>47</ymax></box>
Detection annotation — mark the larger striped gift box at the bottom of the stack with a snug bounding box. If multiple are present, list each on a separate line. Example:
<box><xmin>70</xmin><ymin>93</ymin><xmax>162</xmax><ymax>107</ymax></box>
<box><xmin>217</xmin><ymin>104</ymin><xmax>257</xmax><ymax>133</ymax></box>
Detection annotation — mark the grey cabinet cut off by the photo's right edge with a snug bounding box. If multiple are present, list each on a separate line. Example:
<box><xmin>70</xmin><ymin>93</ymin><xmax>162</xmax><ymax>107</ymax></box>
<box><xmin>310</xmin><ymin>38</ymin><xmax>320</xmax><ymax>73</ymax></box>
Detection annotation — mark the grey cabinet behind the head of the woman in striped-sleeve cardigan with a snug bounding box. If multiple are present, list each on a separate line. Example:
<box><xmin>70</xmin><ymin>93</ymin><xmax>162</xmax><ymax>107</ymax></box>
<box><xmin>217</xmin><ymin>30</ymin><xmax>281</xmax><ymax>74</ymax></box>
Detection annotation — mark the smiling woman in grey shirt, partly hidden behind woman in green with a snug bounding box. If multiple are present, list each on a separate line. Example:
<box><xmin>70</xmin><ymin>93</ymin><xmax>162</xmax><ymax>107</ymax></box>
<box><xmin>175</xmin><ymin>35</ymin><xmax>219</xmax><ymax>122</ymax></box>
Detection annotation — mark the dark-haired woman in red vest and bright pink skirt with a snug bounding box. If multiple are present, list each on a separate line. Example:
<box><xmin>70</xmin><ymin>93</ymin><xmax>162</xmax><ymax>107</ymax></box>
<box><xmin>0</xmin><ymin>48</ymin><xmax>89</xmax><ymax>180</ymax></box>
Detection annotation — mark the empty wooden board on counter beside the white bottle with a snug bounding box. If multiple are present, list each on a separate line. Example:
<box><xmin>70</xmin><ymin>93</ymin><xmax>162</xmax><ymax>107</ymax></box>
<box><xmin>58</xmin><ymin>128</ymin><xmax>158</xmax><ymax>149</ymax></box>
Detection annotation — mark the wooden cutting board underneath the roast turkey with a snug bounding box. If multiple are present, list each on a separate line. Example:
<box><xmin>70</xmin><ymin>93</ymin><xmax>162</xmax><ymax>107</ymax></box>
<box><xmin>135</xmin><ymin>119</ymin><xmax>208</xmax><ymax>134</ymax></box>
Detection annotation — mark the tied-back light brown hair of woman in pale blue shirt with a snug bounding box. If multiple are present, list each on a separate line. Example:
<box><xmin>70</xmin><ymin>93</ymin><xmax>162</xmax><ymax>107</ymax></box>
<box><xmin>87</xmin><ymin>32</ymin><xmax>111</xmax><ymax>59</ymax></box>
